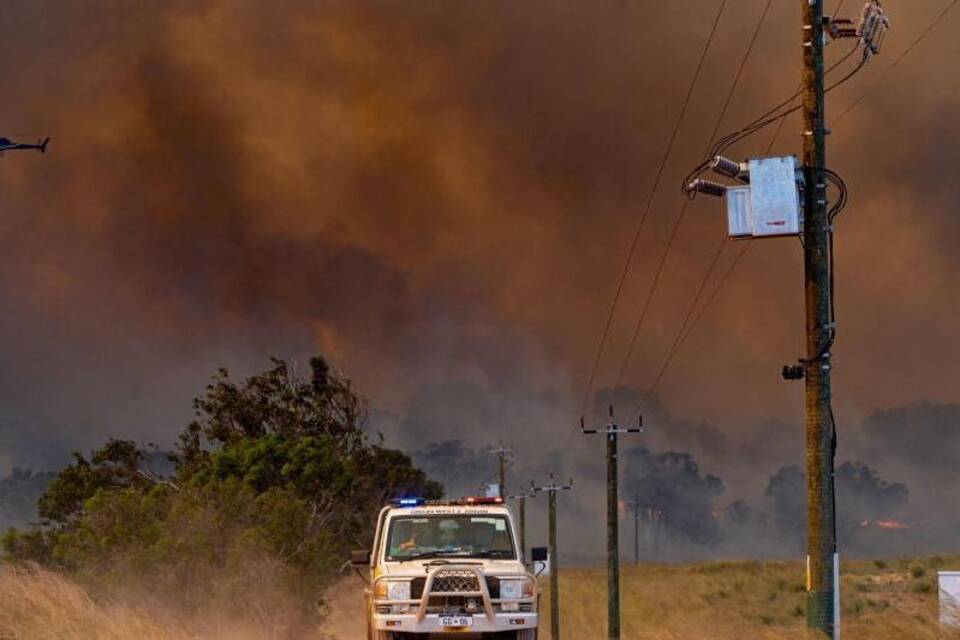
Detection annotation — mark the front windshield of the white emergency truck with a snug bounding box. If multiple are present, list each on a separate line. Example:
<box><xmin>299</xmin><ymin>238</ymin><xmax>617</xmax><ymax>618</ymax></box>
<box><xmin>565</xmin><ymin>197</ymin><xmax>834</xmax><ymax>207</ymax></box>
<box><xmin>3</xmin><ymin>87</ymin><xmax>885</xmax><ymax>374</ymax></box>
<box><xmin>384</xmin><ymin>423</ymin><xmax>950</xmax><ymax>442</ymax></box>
<box><xmin>387</xmin><ymin>515</ymin><xmax>516</xmax><ymax>560</ymax></box>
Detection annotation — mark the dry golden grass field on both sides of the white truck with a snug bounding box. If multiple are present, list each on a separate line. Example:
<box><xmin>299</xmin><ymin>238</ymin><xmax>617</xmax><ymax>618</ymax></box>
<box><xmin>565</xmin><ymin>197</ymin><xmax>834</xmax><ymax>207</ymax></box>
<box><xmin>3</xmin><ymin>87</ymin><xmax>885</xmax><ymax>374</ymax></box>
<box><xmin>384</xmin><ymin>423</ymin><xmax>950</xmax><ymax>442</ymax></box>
<box><xmin>0</xmin><ymin>558</ymin><xmax>960</xmax><ymax>640</ymax></box>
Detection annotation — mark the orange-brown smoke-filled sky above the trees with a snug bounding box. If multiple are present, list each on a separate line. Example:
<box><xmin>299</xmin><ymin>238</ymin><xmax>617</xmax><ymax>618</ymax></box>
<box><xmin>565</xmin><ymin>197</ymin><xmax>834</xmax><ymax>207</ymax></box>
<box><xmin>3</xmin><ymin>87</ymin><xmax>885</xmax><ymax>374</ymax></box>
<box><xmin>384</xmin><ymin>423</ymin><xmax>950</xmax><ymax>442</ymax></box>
<box><xmin>0</xmin><ymin>0</ymin><xmax>960</xmax><ymax>470</ymax></box>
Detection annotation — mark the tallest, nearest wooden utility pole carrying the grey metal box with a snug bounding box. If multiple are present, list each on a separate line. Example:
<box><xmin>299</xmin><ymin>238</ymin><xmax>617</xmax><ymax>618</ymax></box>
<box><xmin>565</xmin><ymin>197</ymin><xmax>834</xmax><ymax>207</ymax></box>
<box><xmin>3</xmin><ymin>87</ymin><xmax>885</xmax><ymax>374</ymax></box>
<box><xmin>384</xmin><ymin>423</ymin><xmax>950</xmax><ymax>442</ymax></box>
<box><xmin>800</xmin><ymin>0</ymin><xmax>839</xmax><ymax>637</ymax></box>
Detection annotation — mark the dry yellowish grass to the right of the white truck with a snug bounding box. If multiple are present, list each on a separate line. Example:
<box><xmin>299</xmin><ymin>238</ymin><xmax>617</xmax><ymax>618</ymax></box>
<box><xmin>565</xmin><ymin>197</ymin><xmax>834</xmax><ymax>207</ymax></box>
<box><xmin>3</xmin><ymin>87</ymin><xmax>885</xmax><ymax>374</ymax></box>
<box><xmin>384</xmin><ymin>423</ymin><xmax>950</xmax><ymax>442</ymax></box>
<box><xmin>542</xmin><ymin>558</ymin><xmax>960</xmax><ymax>640</ymax></box>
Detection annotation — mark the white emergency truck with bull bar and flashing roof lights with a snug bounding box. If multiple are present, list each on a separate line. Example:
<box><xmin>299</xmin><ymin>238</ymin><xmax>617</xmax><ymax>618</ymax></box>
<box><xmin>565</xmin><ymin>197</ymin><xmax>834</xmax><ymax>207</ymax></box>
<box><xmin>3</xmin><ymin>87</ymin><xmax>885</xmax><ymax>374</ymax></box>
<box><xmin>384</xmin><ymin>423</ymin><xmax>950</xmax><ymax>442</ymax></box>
<box><xmin>351</xmin><ymin>497</ymin><xmax>540</xmax><ymax>640</ymax></box>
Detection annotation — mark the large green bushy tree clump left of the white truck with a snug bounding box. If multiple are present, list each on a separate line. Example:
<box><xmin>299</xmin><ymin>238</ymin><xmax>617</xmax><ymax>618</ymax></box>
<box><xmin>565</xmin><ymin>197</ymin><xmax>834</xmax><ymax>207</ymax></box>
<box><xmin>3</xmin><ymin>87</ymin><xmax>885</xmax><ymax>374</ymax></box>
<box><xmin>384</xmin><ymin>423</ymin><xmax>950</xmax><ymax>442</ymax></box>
<box><xmin>3</xmin><ymin>358</ymin><xmax>442</xmax><ymax>617</ymax></box>
